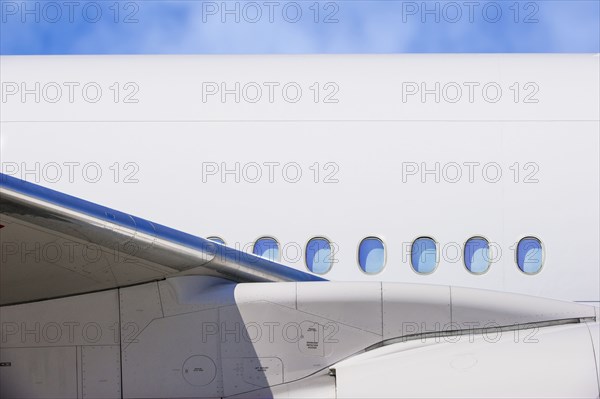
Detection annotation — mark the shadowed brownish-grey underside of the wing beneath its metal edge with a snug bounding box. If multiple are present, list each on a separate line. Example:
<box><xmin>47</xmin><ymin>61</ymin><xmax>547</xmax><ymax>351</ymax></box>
<box><xmin>0</xmin><ymin>214</ymin><xmax>177</xmax><ymax>304</ymax></box>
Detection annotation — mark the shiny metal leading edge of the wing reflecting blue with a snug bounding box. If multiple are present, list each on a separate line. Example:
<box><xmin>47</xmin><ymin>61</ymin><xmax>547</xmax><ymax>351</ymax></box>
<box><xmin>0</xmin><ymin>173</ymin><xmax>326</xmax><ymax>282</ymax></box>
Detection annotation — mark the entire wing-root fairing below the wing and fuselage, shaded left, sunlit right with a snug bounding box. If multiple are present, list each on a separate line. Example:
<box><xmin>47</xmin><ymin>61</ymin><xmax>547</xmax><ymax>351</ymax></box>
<box><xmin>0</xmin><ymin>276</ymin><xmax>598</xmax><ymax>399</ymax></box>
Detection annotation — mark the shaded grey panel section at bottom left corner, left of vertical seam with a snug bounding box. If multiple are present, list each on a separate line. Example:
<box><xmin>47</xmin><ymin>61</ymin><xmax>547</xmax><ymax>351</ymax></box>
<box><xmin>0</xmin><ymin>290</ymin><xmax>121</xmax><ymax>399</ymax></box>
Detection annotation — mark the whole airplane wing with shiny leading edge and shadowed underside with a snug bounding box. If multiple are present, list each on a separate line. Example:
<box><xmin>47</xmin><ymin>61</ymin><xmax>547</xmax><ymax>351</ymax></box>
<box><xmin>0</xmin><ymin>174</ymin><xmax>324</xmax><ymax>305</ymax></box>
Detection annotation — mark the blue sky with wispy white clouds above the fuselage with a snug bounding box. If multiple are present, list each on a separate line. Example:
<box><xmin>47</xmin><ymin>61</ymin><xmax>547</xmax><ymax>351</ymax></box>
<box><xmin>0</xmin><ymin>0</ymin><xmax>600</xmax><ymax>54</ymax></box>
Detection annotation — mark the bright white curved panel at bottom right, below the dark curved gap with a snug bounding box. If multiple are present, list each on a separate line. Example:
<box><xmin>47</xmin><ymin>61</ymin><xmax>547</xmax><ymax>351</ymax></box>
<box><xmin>333</xmin><ymin>323</ymin><xmax>599</xmax><ymax>399</ymax></box>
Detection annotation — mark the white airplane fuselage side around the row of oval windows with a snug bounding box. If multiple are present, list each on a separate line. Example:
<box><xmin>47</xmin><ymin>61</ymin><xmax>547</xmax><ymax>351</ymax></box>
<box><xmin>1</xmin><ymin>55</ymin><xmax>600</xmax><ymax>304</ymax></box>
